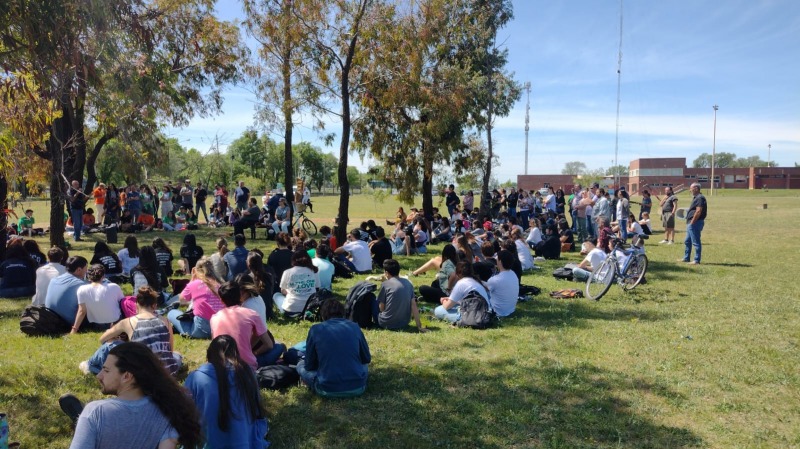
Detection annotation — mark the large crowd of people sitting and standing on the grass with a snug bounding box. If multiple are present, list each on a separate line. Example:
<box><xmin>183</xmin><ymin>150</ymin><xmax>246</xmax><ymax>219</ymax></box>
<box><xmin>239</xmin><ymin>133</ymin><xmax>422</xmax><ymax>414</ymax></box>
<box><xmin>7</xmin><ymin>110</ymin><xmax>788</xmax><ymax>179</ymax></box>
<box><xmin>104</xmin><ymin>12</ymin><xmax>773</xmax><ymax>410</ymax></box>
<box><xmin>0</xmin><ymin>178</ymin><xmax>707</xmax><ymax>447</ymax></box>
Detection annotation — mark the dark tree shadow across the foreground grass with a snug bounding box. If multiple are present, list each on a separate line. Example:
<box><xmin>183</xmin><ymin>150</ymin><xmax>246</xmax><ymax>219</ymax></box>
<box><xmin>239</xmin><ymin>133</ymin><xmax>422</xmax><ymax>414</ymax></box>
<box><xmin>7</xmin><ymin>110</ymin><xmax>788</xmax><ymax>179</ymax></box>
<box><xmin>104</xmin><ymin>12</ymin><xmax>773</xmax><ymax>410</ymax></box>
<box><xmin>271</xmin><ymin>358</ymin><xmax>703</xmax><ymax>449</ymax></box>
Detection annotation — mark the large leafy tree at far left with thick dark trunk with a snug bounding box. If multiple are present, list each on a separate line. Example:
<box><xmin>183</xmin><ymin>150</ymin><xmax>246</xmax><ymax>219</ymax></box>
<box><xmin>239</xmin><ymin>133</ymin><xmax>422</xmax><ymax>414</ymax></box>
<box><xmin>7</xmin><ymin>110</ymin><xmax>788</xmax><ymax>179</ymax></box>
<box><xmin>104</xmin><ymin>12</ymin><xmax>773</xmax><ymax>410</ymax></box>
<box><xmin>0</xmin><ymin>0</ymin><xmax>243</xmax><ymax>245</ymax></box>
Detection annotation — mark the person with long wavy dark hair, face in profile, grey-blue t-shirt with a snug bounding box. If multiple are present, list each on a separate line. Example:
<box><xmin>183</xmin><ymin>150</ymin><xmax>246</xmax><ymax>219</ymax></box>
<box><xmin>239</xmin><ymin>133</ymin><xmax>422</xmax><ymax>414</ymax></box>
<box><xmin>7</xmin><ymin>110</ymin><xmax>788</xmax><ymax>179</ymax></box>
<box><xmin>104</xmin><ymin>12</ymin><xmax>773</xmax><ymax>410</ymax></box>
<box><xmin>58</xmin><ymin>342</ymin><xmax>202</xmax><ymax>449</ymax></box>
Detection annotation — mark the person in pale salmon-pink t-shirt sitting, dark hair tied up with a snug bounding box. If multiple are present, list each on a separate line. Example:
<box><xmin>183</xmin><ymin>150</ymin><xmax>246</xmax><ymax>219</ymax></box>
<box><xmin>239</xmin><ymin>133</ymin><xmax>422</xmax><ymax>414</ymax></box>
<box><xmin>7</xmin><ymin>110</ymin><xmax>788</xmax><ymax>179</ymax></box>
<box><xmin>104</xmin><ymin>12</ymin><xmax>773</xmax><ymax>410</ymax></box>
<box><xmin>211</xmin><ymin>282</ymin><xmax>286</xmax><ymax>369</ymax></box>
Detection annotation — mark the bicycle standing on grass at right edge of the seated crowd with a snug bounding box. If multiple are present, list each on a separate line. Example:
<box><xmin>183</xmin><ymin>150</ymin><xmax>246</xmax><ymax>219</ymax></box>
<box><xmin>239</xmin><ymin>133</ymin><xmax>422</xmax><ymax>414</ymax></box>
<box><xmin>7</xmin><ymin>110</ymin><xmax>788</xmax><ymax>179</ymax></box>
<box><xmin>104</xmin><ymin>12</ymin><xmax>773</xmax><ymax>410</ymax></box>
<box><xmin>585</xmin><ymin>237</ymin><xmax>648</xmax><ymax>301</ymax></box>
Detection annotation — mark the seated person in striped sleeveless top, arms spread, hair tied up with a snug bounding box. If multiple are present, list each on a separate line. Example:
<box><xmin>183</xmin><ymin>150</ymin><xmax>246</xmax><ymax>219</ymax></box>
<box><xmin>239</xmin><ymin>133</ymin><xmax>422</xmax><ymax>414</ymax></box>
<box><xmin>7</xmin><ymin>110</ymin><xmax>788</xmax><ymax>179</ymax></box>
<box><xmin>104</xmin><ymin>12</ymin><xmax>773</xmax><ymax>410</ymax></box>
<box><xmin>78</xmin><ymin>287</ymin><xmax>183</xmax><ymax>376</ymax></box>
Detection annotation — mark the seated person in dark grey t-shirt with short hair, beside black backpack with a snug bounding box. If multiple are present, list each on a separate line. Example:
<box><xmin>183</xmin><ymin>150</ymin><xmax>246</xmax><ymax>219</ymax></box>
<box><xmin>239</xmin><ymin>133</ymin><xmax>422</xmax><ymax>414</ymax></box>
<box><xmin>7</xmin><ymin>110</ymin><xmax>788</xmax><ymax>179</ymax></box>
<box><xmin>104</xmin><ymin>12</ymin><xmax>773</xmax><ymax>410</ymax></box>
<box><xmin>372</xmin><ymin>259</ymin><xmax>427</xmax><ymax>332</ymax></box>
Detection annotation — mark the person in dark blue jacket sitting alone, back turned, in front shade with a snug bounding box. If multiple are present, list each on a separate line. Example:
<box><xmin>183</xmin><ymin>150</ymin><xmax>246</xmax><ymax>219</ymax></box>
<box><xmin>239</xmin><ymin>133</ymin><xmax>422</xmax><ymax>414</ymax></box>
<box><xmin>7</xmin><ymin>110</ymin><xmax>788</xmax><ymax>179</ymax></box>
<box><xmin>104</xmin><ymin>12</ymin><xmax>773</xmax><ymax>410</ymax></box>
<box><xmin>297</xmin><ymin>301</ymin><xmax>372</xmax><ymax>397</ymax></box>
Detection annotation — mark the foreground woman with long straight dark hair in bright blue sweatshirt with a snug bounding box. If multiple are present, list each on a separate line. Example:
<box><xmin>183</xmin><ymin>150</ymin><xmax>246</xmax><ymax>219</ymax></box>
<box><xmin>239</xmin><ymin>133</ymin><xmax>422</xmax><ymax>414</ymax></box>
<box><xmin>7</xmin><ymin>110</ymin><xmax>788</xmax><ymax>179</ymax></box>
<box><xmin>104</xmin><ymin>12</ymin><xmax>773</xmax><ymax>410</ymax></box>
<box><xmin>185</xmin><ymin>335</ymin><xmax>268</xmax><ymax>449</ymax></box>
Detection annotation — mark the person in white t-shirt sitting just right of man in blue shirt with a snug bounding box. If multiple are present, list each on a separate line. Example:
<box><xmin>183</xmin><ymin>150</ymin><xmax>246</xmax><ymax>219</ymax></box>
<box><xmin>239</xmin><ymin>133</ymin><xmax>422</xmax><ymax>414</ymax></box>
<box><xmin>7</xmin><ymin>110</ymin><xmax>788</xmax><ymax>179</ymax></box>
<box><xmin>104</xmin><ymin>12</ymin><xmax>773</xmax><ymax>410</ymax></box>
<box><xmin>70</xmin><ymin>264</ymin><xmax>125</xmax><ymax>334</ymax></box>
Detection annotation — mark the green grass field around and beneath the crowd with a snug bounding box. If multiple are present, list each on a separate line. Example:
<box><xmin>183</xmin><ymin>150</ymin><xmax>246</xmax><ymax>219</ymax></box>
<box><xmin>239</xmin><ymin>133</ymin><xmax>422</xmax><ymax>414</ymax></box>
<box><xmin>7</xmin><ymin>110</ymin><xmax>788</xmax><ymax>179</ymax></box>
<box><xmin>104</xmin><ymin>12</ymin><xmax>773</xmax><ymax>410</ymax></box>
<box><xmin>0</xmin><ymin>190</ymin><xmax>800</xmax><ymax>449</ymax></box>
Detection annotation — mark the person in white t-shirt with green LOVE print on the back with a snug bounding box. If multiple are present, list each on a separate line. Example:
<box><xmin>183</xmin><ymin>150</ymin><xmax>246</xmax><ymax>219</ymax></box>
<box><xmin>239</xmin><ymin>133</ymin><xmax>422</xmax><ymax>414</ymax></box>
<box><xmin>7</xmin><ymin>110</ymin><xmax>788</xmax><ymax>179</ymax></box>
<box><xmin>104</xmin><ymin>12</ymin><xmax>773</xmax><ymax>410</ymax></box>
<box><xmin>272</xmin><ymin>250</ymin><xmax>319</xmax><ymax>314</ymax></box>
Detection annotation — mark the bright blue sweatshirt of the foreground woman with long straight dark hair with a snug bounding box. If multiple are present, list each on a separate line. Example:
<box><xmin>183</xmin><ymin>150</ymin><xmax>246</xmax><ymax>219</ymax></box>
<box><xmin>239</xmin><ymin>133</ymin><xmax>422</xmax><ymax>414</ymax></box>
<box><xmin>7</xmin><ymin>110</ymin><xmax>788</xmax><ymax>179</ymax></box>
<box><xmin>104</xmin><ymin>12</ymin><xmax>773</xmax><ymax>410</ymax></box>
<box><xmin>185</xmin><ymin>363</ymin><xmax>270</xmax><ymax>449</ymax></box>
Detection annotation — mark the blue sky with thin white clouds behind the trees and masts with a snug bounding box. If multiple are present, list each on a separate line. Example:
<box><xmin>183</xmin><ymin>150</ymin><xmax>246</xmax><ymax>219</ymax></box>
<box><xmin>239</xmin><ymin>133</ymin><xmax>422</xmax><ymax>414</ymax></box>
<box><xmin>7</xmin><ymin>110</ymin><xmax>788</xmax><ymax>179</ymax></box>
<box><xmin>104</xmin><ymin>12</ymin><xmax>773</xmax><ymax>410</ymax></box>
<box><xmin>168</xmin><ymin>0</ymin><xmax>800</xmax><ymax>181</ymax></box>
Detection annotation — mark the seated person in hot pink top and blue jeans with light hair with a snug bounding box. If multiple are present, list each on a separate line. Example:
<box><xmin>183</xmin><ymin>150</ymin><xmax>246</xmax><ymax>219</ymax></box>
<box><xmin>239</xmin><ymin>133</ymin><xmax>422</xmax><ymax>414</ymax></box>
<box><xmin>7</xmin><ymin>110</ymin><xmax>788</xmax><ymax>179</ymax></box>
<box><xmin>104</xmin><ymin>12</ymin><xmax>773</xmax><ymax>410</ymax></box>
<box><xmin>167</xmin><ymin>257</ymin><xmax>225</xmax><ymax>338</ymax></box>
